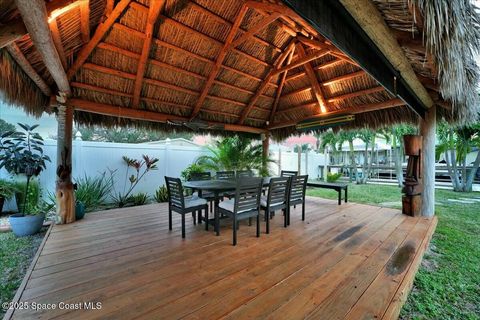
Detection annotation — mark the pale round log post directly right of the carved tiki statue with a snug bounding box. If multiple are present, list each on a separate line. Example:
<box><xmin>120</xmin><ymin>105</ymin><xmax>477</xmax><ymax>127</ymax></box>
<box><xmin>420</xmin><ymin>107</ymin><xmax>437</xmax><ymax>217</ymax></box>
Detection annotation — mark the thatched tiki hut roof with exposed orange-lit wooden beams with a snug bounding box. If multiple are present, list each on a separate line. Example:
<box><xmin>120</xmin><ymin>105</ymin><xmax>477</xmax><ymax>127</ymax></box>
<box><xmin>0</xmin><ymin>0</ymin><xmax>480</xmax><ymax>219</ymax></box>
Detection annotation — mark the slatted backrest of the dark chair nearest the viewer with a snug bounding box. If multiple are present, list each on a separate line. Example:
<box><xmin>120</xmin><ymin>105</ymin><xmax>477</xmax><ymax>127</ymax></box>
<box><xmin>235</xmin><ymin>178</ymin><xmax>262</xmax><ymax>212</ymax></box>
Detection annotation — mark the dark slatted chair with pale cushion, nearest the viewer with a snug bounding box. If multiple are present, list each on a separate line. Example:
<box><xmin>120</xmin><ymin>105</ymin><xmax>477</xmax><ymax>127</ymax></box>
<box><xmin>215</xmin><ymin>178</ymin><xmax>262</xmax><ymax>246</ymax></box>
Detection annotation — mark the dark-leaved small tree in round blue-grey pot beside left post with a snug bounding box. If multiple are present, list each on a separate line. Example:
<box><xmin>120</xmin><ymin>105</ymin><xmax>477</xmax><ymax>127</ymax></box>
<box><xmin>0</xmin><ymin>123</ymin><xmax>50</xmax><ymax>236</ymax></box>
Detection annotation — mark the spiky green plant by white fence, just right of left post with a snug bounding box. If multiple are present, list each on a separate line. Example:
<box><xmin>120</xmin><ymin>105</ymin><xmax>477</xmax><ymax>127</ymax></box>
<box><xmin>75</xmin><ymin>172</ymin><xmax>114</xmax><ymax>212</ymax></box>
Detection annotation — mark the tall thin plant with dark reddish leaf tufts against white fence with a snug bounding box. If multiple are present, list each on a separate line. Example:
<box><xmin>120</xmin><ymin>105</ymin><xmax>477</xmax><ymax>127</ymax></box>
<box><xmin>113</xmin><ymin>155</ymin><xmax>158</xmax><ymax>208</ymax></box>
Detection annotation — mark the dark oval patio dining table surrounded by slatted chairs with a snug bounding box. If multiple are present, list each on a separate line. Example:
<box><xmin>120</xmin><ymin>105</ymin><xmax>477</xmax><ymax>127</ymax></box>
<box><xmin>183</xmin><ymin>177</ymin><xmax>271</xmax><ymax>236</ymax></box>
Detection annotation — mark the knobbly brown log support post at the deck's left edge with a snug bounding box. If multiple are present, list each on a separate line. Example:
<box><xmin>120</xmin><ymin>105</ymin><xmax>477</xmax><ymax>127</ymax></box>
<box><xmin>56</xmin><ymin>103</ymin><xmax>75</xmax><ymax>223</ymax></box>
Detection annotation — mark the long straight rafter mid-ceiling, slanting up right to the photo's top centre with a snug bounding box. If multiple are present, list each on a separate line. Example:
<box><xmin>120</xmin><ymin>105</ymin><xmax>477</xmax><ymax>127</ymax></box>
<box><xmin>190</xmin><ymin>6</ymin><xmax>247</xmax><ymax>119</ymax></box>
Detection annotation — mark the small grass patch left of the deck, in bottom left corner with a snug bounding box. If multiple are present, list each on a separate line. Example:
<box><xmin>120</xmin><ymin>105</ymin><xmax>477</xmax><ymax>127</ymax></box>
<box><xmin>0</xmin><ymin>228</ymin><xmax>45</xmax><ymax>318</ymax></box>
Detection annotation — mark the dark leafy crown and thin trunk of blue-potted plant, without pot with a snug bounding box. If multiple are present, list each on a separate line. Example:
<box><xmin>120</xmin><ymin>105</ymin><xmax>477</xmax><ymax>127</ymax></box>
<box><xmin>0</xmin><ymin>123</ymin><xmax>51</xmax><ymax>215</ymax></box>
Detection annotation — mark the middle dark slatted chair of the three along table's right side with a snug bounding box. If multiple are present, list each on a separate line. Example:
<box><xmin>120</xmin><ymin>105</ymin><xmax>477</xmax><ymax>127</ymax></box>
<box><xmin>260</xmin><ymin>177</ymin><xmax>290</xmax><ymax>233</ymax></box>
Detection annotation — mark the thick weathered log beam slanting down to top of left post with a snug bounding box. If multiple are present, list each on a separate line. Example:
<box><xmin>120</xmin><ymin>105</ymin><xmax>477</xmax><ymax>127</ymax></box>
<box><xmin>15</xmin><ymin>0</ymin><xmax>71</xmax><ymax>95</ymax></box>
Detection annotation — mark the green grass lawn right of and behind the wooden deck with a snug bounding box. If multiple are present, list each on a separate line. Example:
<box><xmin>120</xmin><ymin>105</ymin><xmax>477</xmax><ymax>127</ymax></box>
<box><xmin>307</xmin><ymin>184</ymin><xmax>480</xmax><ymax>319</ymax></box>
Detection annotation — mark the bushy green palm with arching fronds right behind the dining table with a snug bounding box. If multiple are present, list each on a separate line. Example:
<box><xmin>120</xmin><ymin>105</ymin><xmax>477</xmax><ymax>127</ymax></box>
<box><xmin>196</xmin><ymin>136</ymin><xmax>274</xmax><ymax>176</ymax></box>
